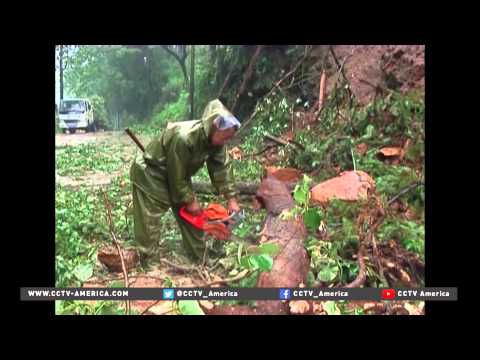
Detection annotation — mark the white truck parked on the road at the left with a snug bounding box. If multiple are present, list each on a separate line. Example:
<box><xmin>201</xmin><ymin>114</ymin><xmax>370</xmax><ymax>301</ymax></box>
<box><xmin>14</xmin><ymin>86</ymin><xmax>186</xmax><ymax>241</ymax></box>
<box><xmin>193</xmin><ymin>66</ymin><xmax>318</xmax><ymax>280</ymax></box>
<box><xmin>58</xmin><ymin>99</ymin><xmax>97</xmax><ymax>134</ymax></box>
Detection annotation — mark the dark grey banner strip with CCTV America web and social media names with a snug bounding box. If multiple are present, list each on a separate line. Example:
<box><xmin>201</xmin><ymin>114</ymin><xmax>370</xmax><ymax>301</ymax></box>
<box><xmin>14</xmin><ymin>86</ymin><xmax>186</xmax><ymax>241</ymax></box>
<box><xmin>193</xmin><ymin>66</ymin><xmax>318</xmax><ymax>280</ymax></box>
<box><xmin>20</xmin><ymin>287</ymin><xmax>457</xmax><ymax>301</ymax></box>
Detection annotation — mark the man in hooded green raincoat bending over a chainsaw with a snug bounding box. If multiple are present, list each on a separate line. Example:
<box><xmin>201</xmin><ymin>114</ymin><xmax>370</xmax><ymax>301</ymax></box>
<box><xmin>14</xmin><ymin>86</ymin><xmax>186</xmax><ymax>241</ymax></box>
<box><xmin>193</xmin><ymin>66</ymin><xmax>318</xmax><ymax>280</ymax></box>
<box><xmin>130</xmin><ymin>100</ymin><xmax>240</xmax><ymax>261</ymax></box>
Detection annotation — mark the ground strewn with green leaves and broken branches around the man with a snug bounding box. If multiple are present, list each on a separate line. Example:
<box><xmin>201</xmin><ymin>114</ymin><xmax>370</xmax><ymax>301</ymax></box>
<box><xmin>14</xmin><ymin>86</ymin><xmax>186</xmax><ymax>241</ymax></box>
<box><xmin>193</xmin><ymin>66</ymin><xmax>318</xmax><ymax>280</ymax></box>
<box><xmin>55</xmin><ymin>88</ymin><xmax>425</xmax><ymax>314</ymax></box>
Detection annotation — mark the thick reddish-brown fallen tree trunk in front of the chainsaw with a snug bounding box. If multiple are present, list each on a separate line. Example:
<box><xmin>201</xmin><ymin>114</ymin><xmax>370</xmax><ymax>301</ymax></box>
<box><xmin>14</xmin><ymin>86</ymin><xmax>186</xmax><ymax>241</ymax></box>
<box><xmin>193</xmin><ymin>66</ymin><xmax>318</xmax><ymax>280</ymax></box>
<box><xmin>205</xmin><ymin>177</ymin><xmax>310</xmax><ymax>315</ymax></box>
